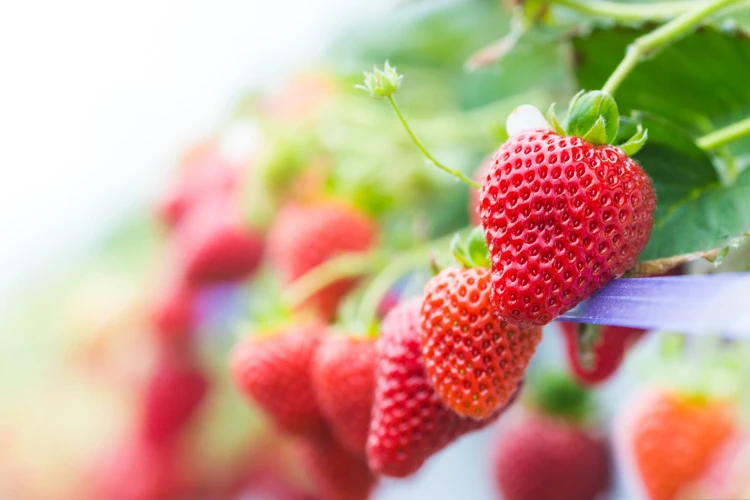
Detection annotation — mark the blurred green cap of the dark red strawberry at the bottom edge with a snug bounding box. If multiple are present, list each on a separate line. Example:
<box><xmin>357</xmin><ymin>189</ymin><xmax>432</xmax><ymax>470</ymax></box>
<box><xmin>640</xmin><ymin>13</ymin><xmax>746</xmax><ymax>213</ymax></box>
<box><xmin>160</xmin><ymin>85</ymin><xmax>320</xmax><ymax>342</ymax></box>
<box><xmin>531</xmin><ymin>372</ymin><xmax>593</xmax><ymax>423</ymax></box>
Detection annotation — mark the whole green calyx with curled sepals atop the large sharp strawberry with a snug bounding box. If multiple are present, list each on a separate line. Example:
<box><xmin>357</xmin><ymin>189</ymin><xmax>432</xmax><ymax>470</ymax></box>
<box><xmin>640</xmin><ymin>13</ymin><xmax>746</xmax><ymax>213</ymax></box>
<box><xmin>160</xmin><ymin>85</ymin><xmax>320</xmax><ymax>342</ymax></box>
<box><xmin>547</xmin><ymin>90</ymin><xmax>648</xmax><ymax>156</ymax></box>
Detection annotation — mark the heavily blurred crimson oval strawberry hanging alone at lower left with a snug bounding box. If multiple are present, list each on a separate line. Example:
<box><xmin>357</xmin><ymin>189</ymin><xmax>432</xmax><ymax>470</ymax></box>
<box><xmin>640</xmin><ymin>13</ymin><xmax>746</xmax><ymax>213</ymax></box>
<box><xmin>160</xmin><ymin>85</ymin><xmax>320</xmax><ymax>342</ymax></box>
<box><xmin>140</xmin><ymin>351</ymin><xmax>209</xmax><ymax>445</ymax></box>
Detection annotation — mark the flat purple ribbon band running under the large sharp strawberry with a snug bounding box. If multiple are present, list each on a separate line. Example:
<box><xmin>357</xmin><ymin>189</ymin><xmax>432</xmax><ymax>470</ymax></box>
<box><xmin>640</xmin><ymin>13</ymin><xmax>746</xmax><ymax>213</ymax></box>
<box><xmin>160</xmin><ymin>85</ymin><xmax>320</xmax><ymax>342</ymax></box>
<box><xmin>558</xmin><ymin>273</ymin><xmax>750</xmax><ymax>339</ymax></box>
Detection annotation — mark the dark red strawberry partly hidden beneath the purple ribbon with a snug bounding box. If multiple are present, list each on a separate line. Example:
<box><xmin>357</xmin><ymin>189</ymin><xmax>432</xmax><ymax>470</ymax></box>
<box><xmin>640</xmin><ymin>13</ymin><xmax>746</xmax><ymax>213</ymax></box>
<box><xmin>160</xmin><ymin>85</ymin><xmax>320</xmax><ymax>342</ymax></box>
<box><xmin>560</xmin><ymin>323</ymin><xmax>646</xmax><ymax>385</ymax></box>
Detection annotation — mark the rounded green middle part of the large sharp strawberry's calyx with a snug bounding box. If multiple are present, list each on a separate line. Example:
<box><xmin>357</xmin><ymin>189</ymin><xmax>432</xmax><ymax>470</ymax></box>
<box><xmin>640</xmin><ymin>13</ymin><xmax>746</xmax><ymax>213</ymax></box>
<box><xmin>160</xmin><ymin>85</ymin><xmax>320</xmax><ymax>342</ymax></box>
<box><xmin>567</xmin><ymin>90</ymin><xmax>620</xmax><ymax>145</ymax></box>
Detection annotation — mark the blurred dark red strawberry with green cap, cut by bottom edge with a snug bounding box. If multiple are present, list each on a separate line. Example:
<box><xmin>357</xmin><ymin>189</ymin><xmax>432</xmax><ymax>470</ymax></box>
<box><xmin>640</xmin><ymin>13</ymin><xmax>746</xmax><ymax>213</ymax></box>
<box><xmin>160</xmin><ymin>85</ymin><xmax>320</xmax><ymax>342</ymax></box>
<box><xmin>493</xmin><ymin>375</ymin><xmax>611</xmax><ymax>500</ymax></box>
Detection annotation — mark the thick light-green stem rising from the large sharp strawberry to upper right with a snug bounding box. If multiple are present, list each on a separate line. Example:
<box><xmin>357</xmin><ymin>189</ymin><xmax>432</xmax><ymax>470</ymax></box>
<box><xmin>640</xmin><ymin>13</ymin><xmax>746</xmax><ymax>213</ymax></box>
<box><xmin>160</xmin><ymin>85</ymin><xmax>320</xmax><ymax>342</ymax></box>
<box><xmin>602</xmin><ymin>0</ymin><xmax>740</xmax><ymax>95</ymax></box>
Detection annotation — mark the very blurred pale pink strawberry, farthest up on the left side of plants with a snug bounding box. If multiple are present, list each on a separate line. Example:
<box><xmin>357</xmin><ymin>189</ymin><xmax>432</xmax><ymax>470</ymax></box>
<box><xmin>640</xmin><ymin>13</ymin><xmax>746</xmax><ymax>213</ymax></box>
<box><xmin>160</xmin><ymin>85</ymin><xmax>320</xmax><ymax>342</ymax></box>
<box><xmin>157</xmin><ymin>144</ymin><xmax>239</xmax><ymax>228</ymax></box>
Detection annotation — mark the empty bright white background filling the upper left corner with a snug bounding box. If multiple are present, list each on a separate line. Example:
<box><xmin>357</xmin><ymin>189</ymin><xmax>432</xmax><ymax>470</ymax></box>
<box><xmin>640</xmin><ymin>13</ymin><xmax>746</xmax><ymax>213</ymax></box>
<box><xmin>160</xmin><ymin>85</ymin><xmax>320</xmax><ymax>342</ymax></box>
<box><xmin>0</xmin><ymin>0</ymin><xmax>394</xmax><ymax>301</ymax></box>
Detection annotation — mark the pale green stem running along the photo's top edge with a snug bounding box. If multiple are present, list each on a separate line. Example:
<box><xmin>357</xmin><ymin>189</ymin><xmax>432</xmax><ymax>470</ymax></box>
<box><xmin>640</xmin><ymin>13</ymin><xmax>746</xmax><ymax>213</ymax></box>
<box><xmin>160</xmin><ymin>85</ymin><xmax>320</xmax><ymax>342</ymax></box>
<box><xmin>551</xmin><ymin>0</ymin><xmax>696</xmax><ymax>22</ymax></box>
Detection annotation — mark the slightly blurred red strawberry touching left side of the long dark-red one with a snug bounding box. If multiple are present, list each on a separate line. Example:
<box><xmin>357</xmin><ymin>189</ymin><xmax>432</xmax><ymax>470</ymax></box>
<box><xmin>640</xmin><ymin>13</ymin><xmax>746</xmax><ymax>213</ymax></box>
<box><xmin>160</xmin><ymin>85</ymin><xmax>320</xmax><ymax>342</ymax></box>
<box><xmin>312</xmin><ymin>335</ymin><xmax>377</xmax><ymax>454</ymax></box>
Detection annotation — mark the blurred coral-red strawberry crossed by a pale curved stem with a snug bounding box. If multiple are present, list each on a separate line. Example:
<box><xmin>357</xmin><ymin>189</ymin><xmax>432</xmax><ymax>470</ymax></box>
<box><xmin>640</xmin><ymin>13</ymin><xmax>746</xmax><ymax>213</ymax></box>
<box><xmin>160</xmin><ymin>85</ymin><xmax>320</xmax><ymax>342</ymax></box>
<box><xmin>268</xmin><ymin>201</ymin><xmax>376</xmax><ymax>320</ymax></box>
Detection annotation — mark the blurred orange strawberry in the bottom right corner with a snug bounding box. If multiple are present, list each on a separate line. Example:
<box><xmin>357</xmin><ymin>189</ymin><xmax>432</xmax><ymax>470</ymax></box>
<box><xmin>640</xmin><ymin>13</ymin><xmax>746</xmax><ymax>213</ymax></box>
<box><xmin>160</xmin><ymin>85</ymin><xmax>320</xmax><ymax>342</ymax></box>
<box><xmin>618</xmin><ymin>389</ymin><xmax>734</xmax><ymax>500</ymax></box>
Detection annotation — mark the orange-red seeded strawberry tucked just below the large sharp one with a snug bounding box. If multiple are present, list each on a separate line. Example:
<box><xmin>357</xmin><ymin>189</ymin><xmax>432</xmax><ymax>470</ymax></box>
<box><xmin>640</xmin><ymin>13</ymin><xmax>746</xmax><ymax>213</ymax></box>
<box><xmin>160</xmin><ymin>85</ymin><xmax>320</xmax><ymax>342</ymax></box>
<box><xmin>419</xmin><ymin>268</ymin><xmax>542</xmax><ymax>420</ymax></box>
